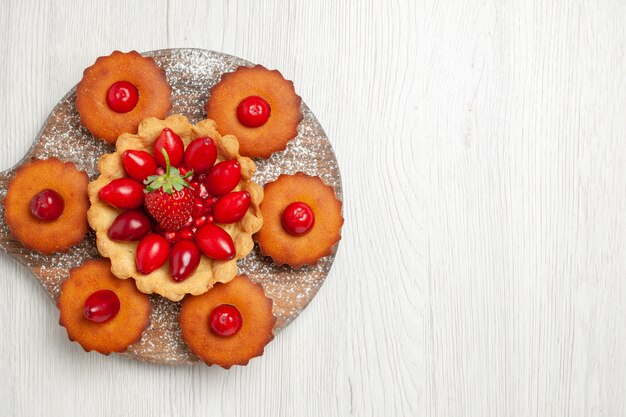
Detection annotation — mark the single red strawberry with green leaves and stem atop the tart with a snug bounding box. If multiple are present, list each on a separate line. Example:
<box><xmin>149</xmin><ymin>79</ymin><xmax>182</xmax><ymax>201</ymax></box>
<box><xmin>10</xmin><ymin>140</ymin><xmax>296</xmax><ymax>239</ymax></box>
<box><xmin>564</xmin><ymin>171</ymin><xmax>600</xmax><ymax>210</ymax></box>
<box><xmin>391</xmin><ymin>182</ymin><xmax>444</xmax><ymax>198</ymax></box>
<box><xmin>144</xmin><ymin>150</ymin><xmax>194</xmax><ymax>231</ymax></box>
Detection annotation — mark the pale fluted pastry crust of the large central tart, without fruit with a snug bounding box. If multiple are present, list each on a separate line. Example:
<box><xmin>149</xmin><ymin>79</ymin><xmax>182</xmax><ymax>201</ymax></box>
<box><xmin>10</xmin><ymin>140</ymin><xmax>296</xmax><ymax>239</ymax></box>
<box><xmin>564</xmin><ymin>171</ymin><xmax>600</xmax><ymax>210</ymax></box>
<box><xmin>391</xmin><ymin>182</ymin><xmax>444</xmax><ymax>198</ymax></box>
<box><xmin>87</xmin><ymin>115</ymin><xmax>263</xmax><ymax>301</ymax></box>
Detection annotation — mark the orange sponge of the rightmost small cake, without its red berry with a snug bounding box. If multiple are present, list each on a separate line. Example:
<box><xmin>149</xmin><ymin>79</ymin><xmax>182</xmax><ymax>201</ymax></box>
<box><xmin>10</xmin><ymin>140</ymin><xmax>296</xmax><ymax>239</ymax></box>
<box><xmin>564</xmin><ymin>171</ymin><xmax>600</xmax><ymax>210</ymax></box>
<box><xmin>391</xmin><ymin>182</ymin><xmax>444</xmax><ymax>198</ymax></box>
<box><xmin>255</xmin><ymin>172</ymin><xmax>343</xmax><ymax>268</ymax></box>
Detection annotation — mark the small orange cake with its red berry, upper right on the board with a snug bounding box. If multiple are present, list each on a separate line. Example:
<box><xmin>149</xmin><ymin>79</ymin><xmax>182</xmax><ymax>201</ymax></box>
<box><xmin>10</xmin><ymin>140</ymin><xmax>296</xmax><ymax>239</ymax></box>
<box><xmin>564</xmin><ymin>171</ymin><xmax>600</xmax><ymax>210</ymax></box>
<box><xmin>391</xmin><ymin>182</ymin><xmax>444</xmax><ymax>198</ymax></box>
<box><xmin>205</xmin><ymin>65</ymin><xmax>302</xmax><ymax>158</ymax></box>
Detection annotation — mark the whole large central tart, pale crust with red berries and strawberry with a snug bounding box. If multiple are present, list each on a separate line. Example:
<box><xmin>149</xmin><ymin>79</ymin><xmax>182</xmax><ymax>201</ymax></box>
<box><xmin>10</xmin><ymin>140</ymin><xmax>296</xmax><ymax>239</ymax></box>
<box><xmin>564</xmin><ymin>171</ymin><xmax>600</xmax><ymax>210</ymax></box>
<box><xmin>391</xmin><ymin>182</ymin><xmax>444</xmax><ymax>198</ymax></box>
<box><xmin>88</xmin><ymin>115</ymin><xmax>263</xmax><ymax>301</ymax></box>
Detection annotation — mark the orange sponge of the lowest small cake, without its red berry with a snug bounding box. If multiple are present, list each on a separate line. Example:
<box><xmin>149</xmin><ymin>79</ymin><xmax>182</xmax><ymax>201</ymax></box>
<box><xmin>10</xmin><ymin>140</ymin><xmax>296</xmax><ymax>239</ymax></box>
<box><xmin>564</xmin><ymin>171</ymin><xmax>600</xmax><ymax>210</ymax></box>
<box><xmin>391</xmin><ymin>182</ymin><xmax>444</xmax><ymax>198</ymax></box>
<box><xmin>178</xmin><ymin>275</ymin><xmax>276</xmax><ymax>369</ymax></box>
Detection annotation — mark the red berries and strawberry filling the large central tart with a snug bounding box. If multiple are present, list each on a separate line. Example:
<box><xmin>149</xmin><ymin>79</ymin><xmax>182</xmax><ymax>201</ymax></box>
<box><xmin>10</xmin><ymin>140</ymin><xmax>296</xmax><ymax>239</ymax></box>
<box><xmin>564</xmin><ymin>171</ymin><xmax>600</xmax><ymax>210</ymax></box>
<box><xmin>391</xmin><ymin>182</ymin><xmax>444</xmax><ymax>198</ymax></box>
<box><xmin>98</xmin><ymin>128</ymin><xmax>250</xmax><ymax>281</ymax></box>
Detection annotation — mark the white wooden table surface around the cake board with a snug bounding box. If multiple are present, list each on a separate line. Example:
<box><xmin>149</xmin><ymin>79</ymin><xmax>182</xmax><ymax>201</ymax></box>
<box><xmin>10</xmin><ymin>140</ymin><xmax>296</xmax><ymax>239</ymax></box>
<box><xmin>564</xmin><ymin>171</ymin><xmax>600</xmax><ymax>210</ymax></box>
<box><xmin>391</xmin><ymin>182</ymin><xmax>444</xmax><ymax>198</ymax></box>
<box><xmin>0</xmin><ymin>0</ymin><xmax>626</xmax><ymax>417</ymax></box>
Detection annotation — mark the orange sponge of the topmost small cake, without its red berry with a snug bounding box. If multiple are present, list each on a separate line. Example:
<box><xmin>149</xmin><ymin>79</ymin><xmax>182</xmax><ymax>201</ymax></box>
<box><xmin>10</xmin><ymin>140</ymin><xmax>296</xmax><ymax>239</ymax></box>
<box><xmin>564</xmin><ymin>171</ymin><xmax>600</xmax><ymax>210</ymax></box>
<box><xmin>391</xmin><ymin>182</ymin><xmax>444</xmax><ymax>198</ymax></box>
<box><xmin>76</xmin><ymin>51</ymin><xmax>172</xmax><ymax>143</ymax></box>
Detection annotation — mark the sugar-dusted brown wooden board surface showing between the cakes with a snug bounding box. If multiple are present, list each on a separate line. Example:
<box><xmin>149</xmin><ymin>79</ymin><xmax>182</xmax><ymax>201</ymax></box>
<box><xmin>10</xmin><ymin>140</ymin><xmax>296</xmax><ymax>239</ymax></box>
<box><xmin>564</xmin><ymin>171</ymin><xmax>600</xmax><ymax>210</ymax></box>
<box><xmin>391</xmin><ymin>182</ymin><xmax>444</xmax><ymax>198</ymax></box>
<box><xmin>0</xmin><ymin>49</ymin><xmax>342</xmax><ymax>364</ymax></box>
